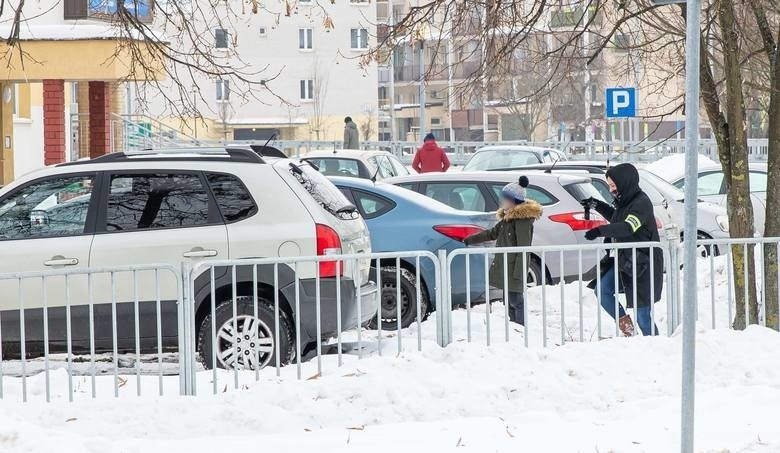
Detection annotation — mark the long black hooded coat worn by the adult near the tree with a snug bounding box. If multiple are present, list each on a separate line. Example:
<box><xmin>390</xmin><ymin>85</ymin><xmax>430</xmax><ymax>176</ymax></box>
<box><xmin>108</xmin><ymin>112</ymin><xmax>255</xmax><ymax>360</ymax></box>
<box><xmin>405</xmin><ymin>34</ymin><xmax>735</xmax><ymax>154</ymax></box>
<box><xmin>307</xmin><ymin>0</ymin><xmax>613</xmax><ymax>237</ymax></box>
<box><xmin>596</xmin><ymin>164</ymin><xmax>664</xmax><ymax>307</ymax></box>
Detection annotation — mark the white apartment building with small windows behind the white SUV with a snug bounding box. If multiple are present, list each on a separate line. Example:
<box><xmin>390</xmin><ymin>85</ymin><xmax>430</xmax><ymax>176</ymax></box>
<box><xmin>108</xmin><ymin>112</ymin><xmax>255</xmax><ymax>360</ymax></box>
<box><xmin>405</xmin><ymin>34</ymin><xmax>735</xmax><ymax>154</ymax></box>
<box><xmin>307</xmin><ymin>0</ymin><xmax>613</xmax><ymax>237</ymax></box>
<box><xmin>145</xmin><ymin>0</ymin><xmax>378</xmax><ymax>141</ymax></box>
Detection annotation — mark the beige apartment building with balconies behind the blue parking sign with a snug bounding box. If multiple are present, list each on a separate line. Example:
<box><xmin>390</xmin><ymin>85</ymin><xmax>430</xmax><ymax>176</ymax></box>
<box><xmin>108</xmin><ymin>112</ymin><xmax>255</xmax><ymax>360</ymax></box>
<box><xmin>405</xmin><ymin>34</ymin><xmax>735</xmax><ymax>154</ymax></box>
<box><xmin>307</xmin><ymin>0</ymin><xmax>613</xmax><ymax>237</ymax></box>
<box><xmin>377</xmin><ymin>0</ymin><xmax>683</xmax><ymax>141</ymax></box>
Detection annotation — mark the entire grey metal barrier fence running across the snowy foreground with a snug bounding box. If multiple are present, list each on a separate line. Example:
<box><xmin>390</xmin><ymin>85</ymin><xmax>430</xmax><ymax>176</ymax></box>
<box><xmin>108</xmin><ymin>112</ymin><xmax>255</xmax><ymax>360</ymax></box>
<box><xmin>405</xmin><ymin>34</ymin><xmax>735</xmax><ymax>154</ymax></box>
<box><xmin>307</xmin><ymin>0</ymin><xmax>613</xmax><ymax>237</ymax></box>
<box><xmin>0</xmin><ymin>237</ymin><xmax>780</xmax><ymax>401</ymax></box>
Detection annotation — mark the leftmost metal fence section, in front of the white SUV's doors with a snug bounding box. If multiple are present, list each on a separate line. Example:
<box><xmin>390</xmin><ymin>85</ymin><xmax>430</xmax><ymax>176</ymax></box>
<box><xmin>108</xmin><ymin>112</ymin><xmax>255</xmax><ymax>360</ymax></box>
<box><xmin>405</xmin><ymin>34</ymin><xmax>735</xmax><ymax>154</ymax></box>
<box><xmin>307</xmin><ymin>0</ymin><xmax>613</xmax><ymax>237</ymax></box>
<box><xmin>0</xmin><ymin>263</ymin><xmax>184</xmax><ymax>402</ymax></box>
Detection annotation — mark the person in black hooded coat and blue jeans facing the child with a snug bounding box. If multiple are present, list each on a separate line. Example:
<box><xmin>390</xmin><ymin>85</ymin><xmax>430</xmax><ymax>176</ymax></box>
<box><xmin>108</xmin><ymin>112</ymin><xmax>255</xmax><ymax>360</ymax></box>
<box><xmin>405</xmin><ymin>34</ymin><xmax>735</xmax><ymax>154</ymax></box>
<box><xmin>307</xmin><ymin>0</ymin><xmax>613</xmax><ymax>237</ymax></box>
<box><xmin>583</xmin><ymin>164</ymin><xmax>663</xmax><ymax>336</ymax></box>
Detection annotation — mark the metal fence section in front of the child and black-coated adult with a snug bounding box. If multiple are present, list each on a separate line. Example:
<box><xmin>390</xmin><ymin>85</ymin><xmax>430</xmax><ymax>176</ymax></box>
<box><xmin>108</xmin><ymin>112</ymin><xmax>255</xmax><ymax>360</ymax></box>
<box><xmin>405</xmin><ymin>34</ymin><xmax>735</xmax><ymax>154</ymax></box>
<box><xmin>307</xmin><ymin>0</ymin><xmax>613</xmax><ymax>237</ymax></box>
<box><xmin>443</xmin><ymin>242</ymin><xmax>677</xmax><ymax>347</ymax></box>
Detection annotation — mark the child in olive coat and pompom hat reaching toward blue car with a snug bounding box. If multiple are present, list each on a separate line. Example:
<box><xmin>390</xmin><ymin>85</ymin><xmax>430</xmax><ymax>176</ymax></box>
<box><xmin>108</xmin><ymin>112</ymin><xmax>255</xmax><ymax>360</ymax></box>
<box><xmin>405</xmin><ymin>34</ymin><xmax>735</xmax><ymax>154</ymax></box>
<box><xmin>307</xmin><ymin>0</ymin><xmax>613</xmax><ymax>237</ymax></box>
<box><xmin>464</xmin><ymin>176</ymin><xmax>542</xmax><ymax>325</ymax></box>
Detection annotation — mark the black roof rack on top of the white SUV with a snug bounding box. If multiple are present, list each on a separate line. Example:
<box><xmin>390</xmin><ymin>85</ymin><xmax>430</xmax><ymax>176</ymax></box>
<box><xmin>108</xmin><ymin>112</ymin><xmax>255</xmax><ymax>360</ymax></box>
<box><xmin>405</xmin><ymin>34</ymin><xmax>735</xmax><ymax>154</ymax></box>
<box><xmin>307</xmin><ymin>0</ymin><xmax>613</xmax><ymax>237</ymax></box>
<box><xmin>57</xmin><ymin>146</ymin><xmax>266</xmax><ymax>167</ymax></box>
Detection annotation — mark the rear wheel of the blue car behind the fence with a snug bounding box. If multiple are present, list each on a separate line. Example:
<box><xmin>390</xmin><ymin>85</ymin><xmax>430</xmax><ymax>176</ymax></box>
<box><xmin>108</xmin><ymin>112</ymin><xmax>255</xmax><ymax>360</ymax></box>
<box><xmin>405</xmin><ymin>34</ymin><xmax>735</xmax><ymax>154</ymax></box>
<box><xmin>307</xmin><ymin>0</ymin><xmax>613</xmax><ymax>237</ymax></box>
<box><xmin>368</xmin><ymin>266</ymin><xmax>429</xmax><ymax>329</ymax></box>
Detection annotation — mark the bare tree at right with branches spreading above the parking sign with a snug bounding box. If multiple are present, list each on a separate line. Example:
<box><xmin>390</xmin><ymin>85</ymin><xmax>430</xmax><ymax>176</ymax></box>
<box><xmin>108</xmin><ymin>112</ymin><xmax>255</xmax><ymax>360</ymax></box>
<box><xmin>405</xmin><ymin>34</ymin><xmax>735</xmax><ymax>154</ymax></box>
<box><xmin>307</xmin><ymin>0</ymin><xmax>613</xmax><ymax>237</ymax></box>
<box><xmin>374</xmin><ymin>0</ymin><xmax>780</xmax><ymax>328</ymax></box>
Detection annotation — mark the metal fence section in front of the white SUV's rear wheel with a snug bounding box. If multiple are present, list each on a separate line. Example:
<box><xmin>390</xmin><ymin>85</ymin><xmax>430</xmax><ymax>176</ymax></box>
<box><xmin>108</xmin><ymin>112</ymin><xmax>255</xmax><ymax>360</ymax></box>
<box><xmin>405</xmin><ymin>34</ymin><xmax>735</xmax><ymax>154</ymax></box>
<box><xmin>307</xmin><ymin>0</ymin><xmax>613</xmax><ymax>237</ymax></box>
<box><xmin>183</xmin><ymin>251</ymin><xmax>441</xmax><ymax>394</ymax></box>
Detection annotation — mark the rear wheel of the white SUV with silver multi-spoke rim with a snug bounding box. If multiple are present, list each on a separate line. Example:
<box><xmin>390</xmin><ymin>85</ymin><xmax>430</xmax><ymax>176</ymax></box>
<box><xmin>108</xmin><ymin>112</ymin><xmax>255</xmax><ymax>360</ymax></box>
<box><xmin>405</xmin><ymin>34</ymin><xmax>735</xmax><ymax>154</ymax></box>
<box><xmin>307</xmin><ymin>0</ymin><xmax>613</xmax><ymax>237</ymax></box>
<box><xmin>198</xmin><ymin>296</ymin><xmax>294</xmax><ymax>370</ymax></box>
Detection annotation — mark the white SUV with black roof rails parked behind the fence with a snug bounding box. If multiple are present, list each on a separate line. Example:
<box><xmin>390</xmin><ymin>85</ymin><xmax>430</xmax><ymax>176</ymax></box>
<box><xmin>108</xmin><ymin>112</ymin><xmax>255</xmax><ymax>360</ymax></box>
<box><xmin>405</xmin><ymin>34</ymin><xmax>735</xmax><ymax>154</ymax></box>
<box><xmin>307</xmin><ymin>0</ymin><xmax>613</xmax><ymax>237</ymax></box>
<box><xmin>0</xmin><ymin>148</ymin><xmax>376</xmax><ymax>368</ymax></box>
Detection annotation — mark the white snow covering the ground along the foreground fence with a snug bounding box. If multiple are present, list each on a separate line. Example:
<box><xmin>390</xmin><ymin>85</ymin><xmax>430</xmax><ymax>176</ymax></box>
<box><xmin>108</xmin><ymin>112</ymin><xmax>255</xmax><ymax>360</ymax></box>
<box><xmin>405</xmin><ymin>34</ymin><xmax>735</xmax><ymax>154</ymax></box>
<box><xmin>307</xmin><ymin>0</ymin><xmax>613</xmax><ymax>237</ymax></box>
<box><xmin>0</xmin><ymin>260</ymin><xmax>780</xmax><ymax>453</ymax></box>
